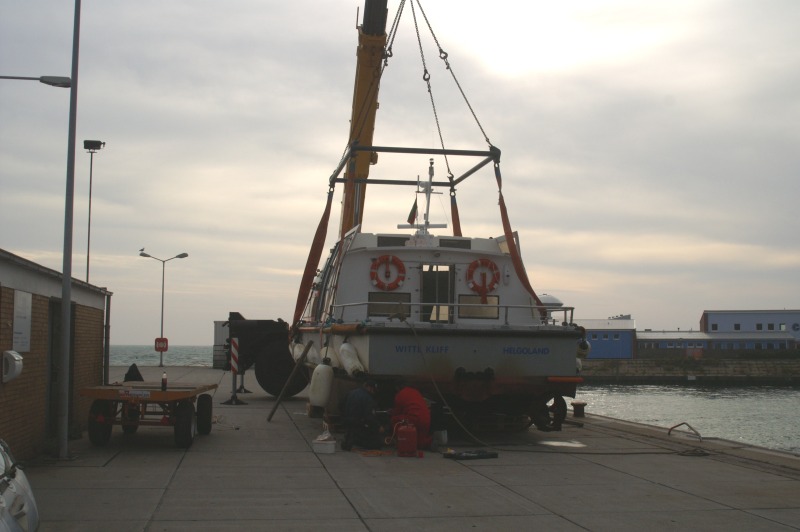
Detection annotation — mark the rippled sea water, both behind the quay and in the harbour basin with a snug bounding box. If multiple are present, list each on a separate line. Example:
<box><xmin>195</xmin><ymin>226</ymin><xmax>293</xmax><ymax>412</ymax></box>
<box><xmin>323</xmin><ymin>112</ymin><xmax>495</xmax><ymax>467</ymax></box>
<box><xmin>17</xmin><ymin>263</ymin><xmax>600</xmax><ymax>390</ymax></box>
<box><xmin>110</xmin><ymin>345</ymin><xmax>800</xmax><ymax>454</ymax></box>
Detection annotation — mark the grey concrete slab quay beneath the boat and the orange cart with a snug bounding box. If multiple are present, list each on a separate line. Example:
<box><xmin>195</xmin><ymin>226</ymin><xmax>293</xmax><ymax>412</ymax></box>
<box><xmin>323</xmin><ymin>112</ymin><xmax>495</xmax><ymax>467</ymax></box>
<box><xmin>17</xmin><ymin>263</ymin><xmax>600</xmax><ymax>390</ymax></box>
<box><xmin>21</xmin><ymin>367</ymin><xmax>800</xmax><ymax>532</ymax></box>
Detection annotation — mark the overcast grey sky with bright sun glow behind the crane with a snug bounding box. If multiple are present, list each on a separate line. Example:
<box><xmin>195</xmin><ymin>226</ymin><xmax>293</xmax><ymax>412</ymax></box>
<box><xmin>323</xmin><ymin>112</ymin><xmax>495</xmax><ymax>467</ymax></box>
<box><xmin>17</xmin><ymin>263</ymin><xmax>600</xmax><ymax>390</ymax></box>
<box><xmin>0</xmin><ymin>0</ymin><xmax>800</xmax><ymax>345</ymax></box>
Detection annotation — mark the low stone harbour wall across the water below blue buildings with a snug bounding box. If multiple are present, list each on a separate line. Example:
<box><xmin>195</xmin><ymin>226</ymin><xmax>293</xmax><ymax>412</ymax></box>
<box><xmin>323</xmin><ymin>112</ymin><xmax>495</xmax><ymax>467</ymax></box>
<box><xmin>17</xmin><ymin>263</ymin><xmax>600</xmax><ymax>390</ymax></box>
<box><xmin>581</xmin><ymin>357</ymin><xmax>800</xmax><ymax>385</ymax></box>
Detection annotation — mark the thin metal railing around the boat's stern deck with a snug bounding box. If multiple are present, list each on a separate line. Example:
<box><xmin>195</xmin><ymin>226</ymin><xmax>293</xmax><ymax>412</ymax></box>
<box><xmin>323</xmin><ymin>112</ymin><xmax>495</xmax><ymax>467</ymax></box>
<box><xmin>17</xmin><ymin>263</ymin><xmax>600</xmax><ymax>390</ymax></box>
<box><xmin>332</xmin><ymin>301</ymin><xmax>575</xmax><ymax>326</ymax></box>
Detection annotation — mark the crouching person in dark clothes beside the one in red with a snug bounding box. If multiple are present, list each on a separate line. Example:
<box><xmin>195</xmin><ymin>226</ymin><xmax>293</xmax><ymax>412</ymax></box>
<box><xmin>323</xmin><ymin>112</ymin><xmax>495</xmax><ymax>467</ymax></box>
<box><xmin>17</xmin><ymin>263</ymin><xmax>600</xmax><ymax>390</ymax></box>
<box><xmin>342</xmin><ymin>381</ymin><xmax>383</xmax><ymax>451</ymax></box>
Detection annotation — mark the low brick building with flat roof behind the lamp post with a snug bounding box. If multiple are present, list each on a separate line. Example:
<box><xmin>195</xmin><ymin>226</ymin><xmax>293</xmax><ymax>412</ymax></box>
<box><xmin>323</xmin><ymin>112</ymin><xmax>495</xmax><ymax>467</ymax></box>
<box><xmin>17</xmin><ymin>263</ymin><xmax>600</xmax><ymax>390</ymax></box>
<box><xmin>0</xmin><ymin>249</ymin><xmax>111</xmax><ymax>459</ymax></box>
